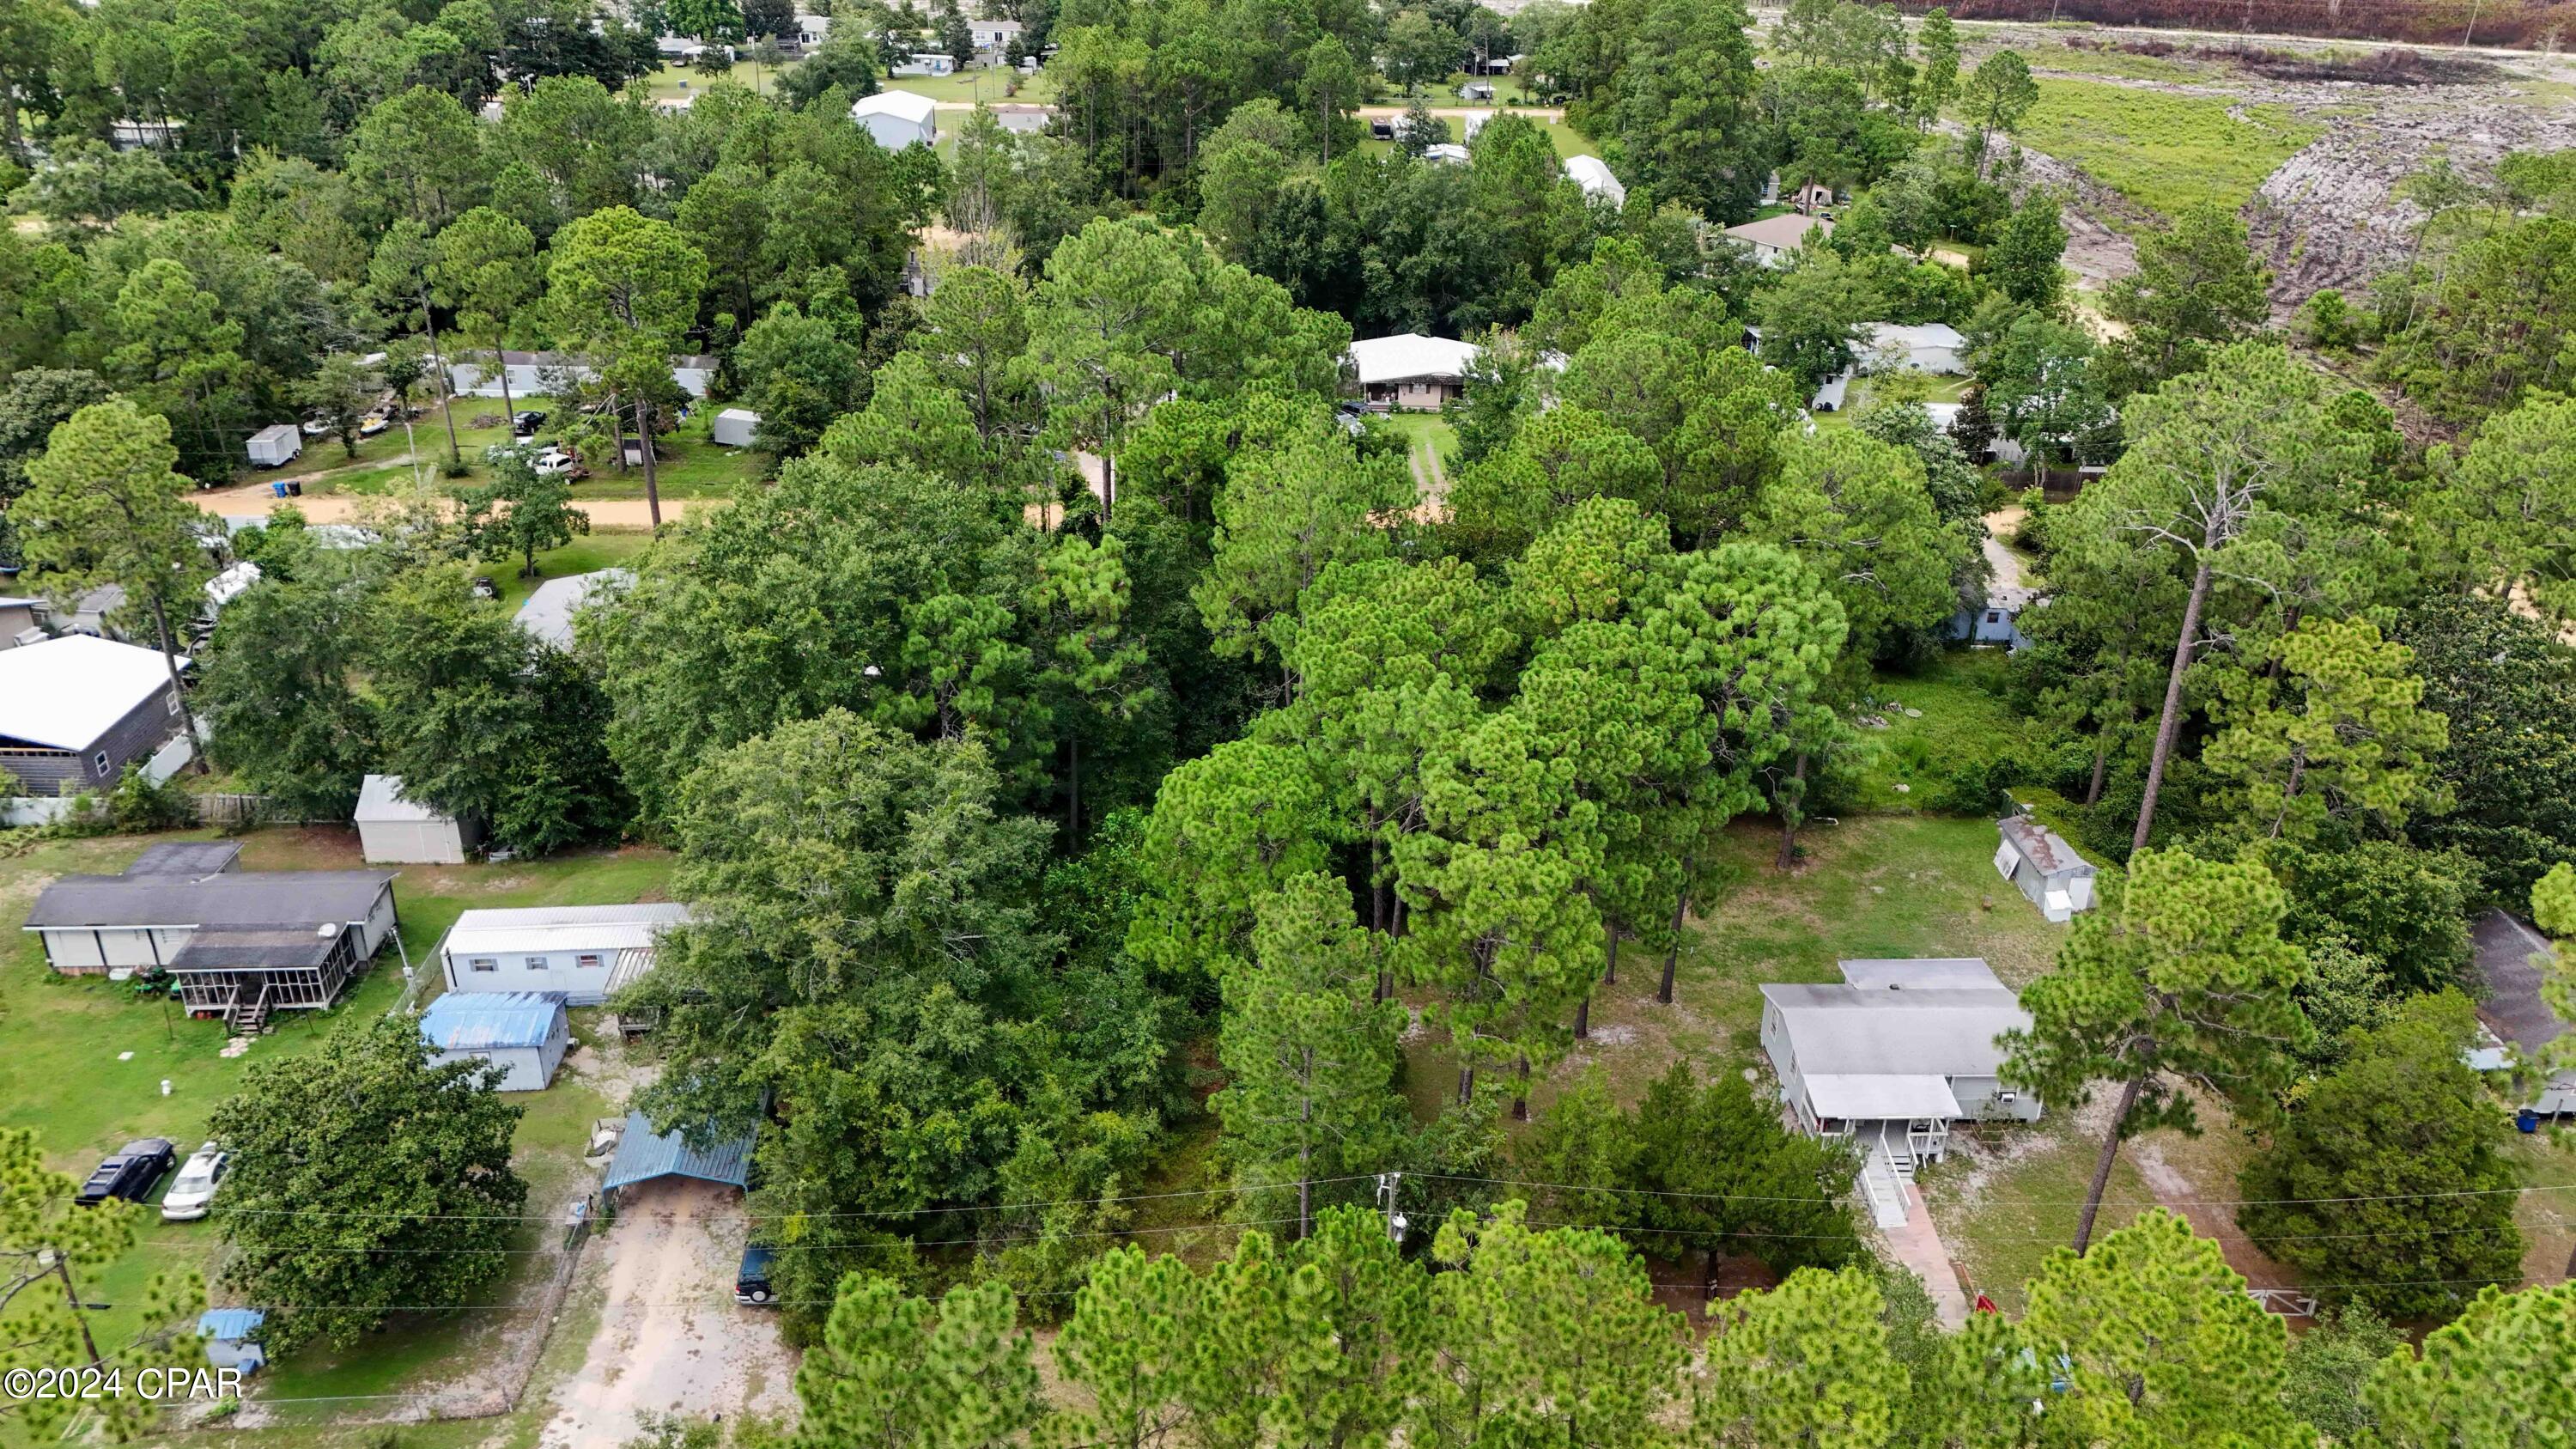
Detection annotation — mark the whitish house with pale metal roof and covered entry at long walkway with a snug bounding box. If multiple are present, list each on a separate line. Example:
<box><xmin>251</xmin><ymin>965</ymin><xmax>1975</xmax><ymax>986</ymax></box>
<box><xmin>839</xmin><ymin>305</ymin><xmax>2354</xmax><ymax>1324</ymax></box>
<box><xmin>1762</xmin><ymin>957</ymin><xmax>2040</xmax><ymax>1225</ymax></box>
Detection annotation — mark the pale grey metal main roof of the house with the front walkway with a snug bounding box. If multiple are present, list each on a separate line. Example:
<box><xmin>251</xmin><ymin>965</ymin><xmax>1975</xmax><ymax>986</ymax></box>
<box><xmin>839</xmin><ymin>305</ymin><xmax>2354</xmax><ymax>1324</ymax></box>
<box><xmin>1762</xmin><ymin>983</ymin><xmax>2030</xmax><ymax>1078</ymax></box>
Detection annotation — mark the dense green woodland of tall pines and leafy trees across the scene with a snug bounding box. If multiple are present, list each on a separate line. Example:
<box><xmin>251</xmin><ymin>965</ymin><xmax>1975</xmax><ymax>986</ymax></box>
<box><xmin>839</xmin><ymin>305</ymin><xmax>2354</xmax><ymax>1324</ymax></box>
<box><xmin>0</xmin><ymin>0</ymin><xmax>2576</xmax><ymax>1446</ymax></box>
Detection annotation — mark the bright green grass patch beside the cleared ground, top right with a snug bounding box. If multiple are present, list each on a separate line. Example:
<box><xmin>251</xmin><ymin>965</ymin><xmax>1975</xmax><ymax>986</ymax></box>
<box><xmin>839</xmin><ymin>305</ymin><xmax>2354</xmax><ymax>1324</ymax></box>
<box><xmin>2022</xmin><ymin>80</ymin><xmax>2324</xmax><ymax>216</ymax></box>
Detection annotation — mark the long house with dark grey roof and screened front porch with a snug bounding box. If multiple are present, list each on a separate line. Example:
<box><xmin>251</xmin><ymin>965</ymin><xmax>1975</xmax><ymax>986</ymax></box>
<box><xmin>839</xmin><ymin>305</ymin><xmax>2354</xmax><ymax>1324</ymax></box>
<box><xmin>23</xmin><ymin>859</ymin><xmax>394</xmax><ymax>1032</ymax></box>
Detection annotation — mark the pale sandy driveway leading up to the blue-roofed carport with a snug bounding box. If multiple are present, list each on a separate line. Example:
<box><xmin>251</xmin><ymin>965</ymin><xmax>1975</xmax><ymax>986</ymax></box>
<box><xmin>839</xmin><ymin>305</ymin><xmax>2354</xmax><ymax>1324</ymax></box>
<box><xmin>538</xmin><ymin>1178</ymin><xmax>796</xmax><ymax>1449</ymax></box>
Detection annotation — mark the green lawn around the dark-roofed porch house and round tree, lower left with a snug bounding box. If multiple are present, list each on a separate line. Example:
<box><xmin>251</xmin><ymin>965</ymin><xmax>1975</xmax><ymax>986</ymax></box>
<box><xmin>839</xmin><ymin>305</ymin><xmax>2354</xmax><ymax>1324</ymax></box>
<box><xmin>0</xmin><ymin>828</ymin><xmax>672</xmax><ymax>1397</ymax></box>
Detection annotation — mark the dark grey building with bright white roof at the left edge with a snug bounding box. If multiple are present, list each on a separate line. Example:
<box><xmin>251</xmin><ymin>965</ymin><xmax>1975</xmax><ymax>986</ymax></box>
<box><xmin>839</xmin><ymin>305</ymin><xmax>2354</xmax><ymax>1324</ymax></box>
<box><xmin>0</xmin><ymin>634</ymin><xmax>188</xmax><ymax>795</ymax></box>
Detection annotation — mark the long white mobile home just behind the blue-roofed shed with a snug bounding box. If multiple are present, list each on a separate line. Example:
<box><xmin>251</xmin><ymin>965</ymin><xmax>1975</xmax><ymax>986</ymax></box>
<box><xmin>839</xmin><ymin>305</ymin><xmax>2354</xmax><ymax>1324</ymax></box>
<box><xmin>438</xmin><ymin>903</ymin><xmax>688</xmax><ymax>1006</ymax></box>
